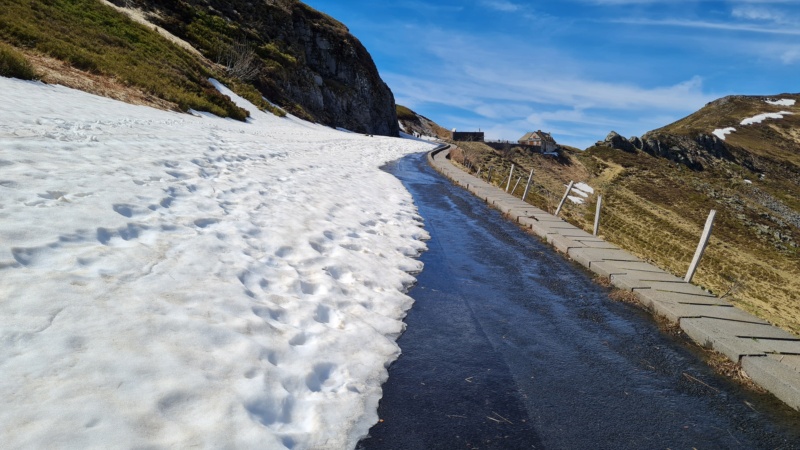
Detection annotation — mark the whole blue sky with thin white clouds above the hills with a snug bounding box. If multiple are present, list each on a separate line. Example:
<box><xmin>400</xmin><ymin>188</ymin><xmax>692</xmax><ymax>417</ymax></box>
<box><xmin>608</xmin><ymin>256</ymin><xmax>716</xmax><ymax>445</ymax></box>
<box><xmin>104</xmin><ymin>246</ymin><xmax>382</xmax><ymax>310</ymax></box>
<box><xmin>305</xmin><ymin>0</ymin><xmax>800</xmax><ymax>148</ymax></box>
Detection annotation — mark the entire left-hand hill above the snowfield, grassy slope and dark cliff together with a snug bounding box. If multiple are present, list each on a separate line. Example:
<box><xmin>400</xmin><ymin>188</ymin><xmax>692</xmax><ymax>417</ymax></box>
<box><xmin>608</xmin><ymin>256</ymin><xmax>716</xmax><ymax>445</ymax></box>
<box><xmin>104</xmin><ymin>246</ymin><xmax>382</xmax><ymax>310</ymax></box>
<box><xmin>0</xmin><ymin>0</ymin><xmax>399</xmax><ymax>136</ymax></box>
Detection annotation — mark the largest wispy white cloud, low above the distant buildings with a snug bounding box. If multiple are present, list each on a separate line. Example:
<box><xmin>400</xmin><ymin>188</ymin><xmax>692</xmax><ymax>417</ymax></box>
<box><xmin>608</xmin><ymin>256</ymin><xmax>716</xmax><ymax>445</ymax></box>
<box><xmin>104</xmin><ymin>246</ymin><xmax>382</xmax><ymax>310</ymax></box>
<box><xmin>384</xmin><ymin>25</ymin><xmax>717</xmax><ymax>146</ymax></box>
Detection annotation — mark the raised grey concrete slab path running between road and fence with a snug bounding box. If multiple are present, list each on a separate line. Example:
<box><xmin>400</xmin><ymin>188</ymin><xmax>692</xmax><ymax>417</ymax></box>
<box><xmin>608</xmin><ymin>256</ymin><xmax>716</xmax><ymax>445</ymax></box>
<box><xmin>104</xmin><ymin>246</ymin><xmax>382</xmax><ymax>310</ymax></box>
<box><xmin>428</xmin><ymin>146</ymin><xmax>800</xmax><ymax>410</ymax></box>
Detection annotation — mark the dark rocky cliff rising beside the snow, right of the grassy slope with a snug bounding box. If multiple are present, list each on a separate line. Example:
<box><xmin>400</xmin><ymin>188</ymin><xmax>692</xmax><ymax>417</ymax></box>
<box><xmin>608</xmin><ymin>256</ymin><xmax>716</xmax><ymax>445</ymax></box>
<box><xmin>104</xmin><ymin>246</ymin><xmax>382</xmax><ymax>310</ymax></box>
<box><xmin>114</xmin><ymin>0</ymin><xmax>399</xmax><ymax>136</ymax></box>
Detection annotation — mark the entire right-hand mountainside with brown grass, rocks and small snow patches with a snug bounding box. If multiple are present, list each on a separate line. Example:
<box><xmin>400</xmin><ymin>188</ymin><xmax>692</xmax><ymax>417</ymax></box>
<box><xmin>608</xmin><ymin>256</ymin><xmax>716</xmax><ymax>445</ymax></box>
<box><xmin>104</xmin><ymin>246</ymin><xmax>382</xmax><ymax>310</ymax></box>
<box><xmin>444</xmin><ymin>94</ymin><xmax>800</xmax><ymax>335</ymax></box>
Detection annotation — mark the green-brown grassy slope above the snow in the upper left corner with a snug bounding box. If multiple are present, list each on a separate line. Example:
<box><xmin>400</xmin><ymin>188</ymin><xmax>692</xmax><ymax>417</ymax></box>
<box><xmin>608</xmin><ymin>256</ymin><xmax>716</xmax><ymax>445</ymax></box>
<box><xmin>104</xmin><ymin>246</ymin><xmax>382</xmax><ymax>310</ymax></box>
<box><xmin>0</xmin><ymin>0</ymin><xmax>278</xmax><ymax>120</ymax></box>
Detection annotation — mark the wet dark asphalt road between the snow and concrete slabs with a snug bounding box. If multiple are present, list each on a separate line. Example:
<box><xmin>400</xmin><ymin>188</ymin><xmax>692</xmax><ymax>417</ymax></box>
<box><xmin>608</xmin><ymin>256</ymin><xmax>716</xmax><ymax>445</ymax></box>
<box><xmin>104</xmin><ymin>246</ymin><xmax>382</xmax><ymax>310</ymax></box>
<box><xmin>358</xmin><ymin>155</ymin><xmax>800</xmax><ymax>450</ymax></box>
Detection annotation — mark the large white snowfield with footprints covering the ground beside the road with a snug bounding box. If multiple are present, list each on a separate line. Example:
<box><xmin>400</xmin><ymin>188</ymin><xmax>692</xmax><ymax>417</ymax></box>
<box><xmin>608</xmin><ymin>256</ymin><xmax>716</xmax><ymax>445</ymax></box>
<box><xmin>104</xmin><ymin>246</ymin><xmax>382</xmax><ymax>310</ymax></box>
<box><xmin>0</xmin><ymin>78</ymin><xmax>431</xmax><ymax>449</ymax></box>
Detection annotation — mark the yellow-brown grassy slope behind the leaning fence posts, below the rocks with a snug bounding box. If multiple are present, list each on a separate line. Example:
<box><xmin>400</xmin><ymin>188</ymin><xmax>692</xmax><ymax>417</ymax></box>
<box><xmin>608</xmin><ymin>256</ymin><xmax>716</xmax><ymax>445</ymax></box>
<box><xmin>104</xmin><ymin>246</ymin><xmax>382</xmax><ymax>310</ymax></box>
<box><xmin>453</xmin><ymin>128</ymin><xmax>800</xmax><ymax>335</ymax></box>
